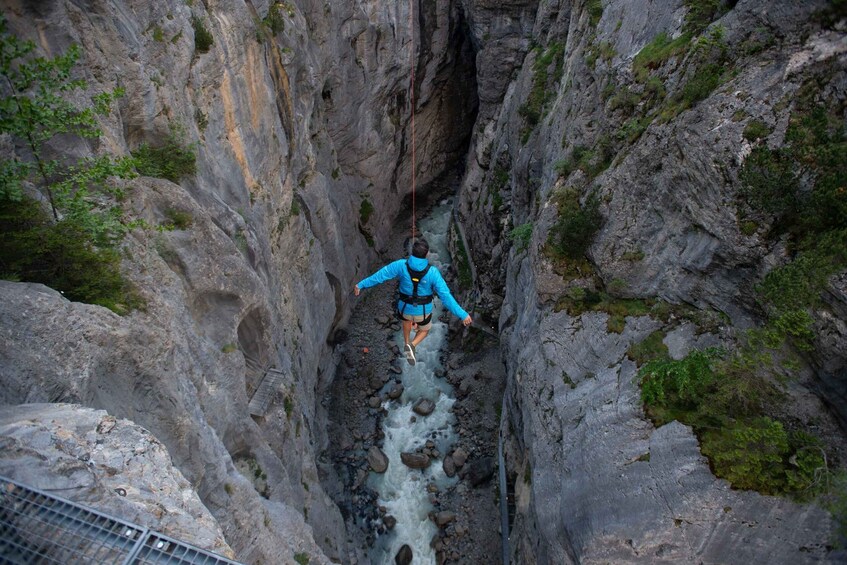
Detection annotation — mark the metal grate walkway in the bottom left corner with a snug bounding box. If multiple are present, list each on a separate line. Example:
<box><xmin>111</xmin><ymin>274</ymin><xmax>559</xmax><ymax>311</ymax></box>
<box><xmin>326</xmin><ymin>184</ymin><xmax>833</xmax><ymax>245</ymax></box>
<box><xmin>0</xmin><ymin>477</ymin><xmax>245</xmax><ymax>565</ymax></box>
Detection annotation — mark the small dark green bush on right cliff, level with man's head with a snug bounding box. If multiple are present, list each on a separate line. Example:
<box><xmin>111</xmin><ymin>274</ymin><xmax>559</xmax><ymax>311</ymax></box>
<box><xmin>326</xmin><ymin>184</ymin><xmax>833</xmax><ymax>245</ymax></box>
<box><xmin>548</xmin><ymin>191</ymin><xmax>603</xmax><ymax>259</ymax></box>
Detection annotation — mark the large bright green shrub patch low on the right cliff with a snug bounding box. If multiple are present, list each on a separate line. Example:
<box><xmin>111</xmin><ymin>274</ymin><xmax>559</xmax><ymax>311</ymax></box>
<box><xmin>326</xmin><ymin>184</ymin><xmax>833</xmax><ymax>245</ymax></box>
<box><xmin>638</xmin><ymin>350</ymin><xmax>827</xmax><ymax>500</ymax></box>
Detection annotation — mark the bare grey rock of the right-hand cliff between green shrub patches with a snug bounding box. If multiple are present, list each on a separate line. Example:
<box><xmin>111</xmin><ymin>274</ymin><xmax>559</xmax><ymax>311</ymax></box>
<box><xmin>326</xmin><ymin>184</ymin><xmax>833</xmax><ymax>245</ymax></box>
<box><xmin>454</xmin><ymin>0</ymin><xmax>847</xmax><ymax>564</ymax></box>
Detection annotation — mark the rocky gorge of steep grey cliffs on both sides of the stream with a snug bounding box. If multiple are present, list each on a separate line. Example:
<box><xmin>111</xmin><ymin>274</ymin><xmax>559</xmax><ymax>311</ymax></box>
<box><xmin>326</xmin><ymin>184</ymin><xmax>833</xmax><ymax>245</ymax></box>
<box><xmin>0</xmin><ymin>0</ymin><xmax>847</xmax><ymax>564</ymax></box>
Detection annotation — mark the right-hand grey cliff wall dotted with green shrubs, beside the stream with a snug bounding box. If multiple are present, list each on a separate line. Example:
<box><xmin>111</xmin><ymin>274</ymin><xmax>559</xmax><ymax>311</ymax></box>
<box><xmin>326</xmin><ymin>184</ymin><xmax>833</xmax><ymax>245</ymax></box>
<box><xmin>460</xmin><ymin>0</ymin><xmax>847</xmax><ymax>563</ymax></box>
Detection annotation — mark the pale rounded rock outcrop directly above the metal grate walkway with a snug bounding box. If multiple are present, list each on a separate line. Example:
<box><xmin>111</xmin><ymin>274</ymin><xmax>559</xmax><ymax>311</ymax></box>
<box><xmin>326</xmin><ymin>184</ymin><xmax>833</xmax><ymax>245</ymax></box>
<box><xmin>0</xmin><ymin>404</ymin><xmax>233</xmax><ymax>558</ymax></box>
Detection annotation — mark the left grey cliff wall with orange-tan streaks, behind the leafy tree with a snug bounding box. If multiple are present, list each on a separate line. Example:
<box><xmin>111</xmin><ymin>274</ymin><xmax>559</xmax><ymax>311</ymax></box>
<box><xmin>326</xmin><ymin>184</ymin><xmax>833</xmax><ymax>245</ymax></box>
<box><xmin>0</xmin><ymin>0</ymin><xmax>476</xmax><ymax>563</ymax></box>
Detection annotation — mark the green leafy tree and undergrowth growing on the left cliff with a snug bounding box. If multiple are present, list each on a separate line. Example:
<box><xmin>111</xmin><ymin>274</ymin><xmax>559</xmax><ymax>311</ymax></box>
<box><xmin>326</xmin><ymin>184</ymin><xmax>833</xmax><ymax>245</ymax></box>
<box><xmin>0</xmin><ymin>15</ymin><xmax>142</xmax><ymax>312</ymax></box>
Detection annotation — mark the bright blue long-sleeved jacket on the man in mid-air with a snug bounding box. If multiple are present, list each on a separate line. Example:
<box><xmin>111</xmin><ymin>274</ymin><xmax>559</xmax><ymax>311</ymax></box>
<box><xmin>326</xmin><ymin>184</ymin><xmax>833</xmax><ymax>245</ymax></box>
<box><xmin>356</xmin><ymin>256</ymin><xmax>468</xmax><ymax>320</ymax></box>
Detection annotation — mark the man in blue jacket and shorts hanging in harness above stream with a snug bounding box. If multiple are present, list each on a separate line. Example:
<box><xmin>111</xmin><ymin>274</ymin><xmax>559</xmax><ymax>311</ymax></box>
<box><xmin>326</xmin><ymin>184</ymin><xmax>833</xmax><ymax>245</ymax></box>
<box><xmin>353</xmin><ymin>238</ymin><xmax>473</xmax><ymax>365</ymax></box>
